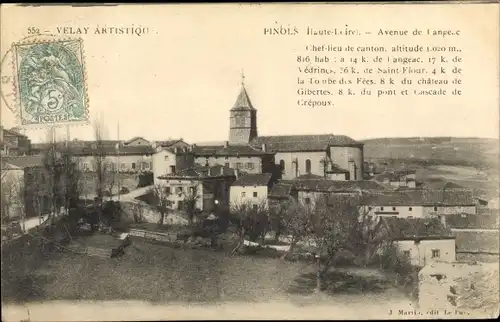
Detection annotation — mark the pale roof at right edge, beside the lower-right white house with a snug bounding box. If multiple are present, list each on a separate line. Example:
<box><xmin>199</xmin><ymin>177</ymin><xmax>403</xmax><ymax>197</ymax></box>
<box><xmin>453</xmin><ymin>230</ymin><xmax>500</xmax><ymax>254</ymax></box>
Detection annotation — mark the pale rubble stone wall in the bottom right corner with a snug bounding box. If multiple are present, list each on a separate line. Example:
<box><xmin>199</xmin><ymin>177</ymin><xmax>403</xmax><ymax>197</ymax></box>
<box><xmin>419</xmin><ymin>262</ymin><xmax>500</xmax><ymax>317</ymax></box>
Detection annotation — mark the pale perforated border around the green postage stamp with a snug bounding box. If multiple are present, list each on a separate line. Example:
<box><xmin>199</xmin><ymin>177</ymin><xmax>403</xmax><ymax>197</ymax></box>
<box><xmin>10</xmin><ymin>34</ymin><xmax>90</xmax><ymax>130</ymax></box>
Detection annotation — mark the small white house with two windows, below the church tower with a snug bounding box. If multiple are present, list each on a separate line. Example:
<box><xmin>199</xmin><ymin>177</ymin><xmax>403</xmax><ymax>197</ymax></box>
<box><xmin>230</xmin><ymin>173</ymin><xmax>273</xmax><ymax>207</ymax></box>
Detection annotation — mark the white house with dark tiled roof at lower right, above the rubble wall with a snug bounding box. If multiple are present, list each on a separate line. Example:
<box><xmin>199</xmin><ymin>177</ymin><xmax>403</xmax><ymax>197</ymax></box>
<box><xmin>380</xmin><ymin>217</ymin><xmax>456</xmax><ymax>267</ymax></box>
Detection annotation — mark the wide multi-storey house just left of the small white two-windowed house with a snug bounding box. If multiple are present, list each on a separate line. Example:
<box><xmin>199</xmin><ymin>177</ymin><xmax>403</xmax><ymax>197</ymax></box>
<box><xmin>157</xmin><ymin>165</ymin><xmax>240</xmax><ymax>212</ymax></box>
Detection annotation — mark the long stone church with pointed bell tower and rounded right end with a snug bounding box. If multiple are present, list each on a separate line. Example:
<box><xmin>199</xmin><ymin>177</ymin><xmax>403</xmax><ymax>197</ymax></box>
<box><xmin>194</xmin><ymin>80</ymin><xmax>363</xmax><ymax>180</ymax></box>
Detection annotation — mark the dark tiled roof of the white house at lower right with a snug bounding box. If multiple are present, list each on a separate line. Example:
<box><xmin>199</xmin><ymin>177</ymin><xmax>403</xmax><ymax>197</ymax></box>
<box><xmin>381</xmin><ymin>217</ymin><xmax>453</xmax><ymax>240</ymax></box>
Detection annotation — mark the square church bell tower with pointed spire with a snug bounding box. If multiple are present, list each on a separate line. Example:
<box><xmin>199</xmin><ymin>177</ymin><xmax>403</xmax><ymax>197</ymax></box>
<box><xmin>229</xmin><ymin>75</ymin><xmax>257</xmax><ymax>145</ymax></box>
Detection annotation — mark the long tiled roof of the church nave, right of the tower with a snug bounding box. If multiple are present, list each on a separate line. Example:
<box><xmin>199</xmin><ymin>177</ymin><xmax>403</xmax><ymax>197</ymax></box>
<box><xmin>251</xmin><ymin>134</ymin><xmax>362</xmax><ymax>152</ymax></box>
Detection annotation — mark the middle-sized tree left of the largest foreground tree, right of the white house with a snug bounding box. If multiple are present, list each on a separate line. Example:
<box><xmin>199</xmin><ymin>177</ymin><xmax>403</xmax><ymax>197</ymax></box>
<box><xmin>271</xmin><ymin>199</ymin><xmax>314</xmax><ymax>259</ymax></box>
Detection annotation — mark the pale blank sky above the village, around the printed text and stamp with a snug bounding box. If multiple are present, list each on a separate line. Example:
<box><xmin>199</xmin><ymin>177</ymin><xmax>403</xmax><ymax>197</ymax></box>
<box><xmin>0</xmin><ymin>4</ymin><xmax>499</xmax><ymax>142</ymax></box>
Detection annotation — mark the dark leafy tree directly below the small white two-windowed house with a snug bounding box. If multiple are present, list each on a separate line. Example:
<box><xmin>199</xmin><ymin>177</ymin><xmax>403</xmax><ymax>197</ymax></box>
<box><xmin>230</xmin><ymin>200</ymin><xmax>269</xmax><ymax>253</ymax></box>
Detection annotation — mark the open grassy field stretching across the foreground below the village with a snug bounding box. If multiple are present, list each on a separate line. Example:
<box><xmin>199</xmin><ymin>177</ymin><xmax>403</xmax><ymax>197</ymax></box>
<box><xmin>2</xmin><ymin>235</ymin><xmax>409</xmax><ymax>305</ymax></box>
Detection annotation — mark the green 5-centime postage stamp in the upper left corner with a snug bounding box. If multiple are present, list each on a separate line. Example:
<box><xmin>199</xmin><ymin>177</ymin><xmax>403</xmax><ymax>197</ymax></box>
<box><xmin>14</xmin><ymin>40</ymin><xmax>89</xmax><ymax>126</ymax></box>
